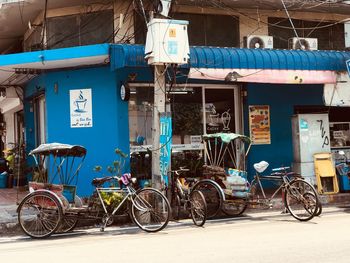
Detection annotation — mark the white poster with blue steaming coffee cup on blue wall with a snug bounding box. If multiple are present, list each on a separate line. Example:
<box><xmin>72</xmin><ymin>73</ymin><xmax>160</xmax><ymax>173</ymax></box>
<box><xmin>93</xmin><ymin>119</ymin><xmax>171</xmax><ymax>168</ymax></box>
<box><xmin>69</xmin><ymin>89</ymin><xmax>92</xmax><ymax>128</ymax></box>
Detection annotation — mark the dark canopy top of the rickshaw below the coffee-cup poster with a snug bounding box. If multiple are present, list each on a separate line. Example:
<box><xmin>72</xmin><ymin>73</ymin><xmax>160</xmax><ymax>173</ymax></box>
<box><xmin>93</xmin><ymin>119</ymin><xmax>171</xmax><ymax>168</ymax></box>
<box><xmin>29</xmin><ymin>142</ymin><xmax>87</xmax><ymax>157</ymax></box>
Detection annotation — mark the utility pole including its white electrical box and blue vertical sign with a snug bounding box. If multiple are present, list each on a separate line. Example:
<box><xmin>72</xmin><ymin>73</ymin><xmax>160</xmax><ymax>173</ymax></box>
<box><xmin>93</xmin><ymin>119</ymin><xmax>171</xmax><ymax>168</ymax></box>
<box><xmin>145</xmin><ymin>4</ymin><xmax>190</xmax><ymax>190</ymax></box>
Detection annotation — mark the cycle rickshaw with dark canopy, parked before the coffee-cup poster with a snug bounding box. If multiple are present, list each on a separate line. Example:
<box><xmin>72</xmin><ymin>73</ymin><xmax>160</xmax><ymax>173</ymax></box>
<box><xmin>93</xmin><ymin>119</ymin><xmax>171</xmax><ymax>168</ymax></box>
<box><xmin>17</xmin><ymin>143</ymin><xmax>170</xmax><ymax>238</ymax></box>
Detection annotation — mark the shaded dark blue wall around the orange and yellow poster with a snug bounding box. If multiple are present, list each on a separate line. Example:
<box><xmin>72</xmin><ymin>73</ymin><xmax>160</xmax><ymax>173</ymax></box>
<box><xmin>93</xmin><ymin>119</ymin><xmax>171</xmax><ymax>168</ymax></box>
<box><xmin>244</xmin><ymin>84</ymin><xmax>323</xmax><ymax>183</ymax></box>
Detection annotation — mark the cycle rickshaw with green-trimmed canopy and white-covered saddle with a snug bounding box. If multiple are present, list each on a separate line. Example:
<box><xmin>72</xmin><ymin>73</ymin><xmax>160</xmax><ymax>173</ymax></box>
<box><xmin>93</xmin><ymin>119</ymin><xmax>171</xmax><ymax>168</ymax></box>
<box><xmin>193</xmin><ymin>133</ymin><xmax>321</xmax><ymax>221</ymax></box>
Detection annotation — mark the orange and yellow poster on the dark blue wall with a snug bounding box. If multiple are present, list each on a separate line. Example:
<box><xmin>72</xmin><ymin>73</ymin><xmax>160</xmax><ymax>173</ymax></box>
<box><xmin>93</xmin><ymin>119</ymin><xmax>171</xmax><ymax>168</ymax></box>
<box><xmin>249</xmin><ymin>105</ymin><xmax>271</xmax><ymax>144</ymax></box>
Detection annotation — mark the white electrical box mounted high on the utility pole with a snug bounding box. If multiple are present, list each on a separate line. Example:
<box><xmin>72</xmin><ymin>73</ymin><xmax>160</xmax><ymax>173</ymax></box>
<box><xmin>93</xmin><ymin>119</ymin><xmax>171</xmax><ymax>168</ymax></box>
<box><xmin>145</xmin><ymin>18</ymin><xmax>190</xmax><ymax>65</ymax></box>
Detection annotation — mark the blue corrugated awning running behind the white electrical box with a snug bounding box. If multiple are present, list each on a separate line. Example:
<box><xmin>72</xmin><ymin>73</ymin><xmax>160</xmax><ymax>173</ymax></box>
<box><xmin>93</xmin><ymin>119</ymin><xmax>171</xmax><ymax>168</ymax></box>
<box><xmin>110</xmin><ymin>44</ymin><xmax>350</xmax><ymax>71</ymax></box>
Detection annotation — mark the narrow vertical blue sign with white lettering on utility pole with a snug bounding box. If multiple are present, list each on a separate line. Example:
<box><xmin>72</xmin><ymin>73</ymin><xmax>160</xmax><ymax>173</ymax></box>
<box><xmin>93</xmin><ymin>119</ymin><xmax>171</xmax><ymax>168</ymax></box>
<box><xmin>159</xmin><ymin>115</ymin><xmax>172</xmax><ymax>186</ymax></box>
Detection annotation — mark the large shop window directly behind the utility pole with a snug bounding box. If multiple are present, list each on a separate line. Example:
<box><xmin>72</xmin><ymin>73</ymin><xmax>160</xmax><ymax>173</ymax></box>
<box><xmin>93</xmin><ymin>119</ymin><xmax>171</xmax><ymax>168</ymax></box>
<box><xmin>129</xmin><ymin>87</ymin><xmax>203</xmax><ymax>145</ymax></box>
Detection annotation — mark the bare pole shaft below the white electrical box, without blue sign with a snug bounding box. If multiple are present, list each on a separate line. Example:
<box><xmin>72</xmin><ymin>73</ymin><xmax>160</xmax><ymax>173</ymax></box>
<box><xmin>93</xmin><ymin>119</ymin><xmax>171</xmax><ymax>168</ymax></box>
<box><xmin>152</xmin><ymin>65</ymin><xmax>166</xmax><ymax>189</ymax></box>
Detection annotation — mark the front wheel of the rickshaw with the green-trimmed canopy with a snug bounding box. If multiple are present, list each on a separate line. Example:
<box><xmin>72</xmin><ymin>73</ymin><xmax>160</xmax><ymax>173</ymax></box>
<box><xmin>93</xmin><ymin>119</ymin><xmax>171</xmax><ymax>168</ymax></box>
<box><xmin>284</xmin><ymin>179</ymin><xmax>319</xmax><ymax>221</ymax></box>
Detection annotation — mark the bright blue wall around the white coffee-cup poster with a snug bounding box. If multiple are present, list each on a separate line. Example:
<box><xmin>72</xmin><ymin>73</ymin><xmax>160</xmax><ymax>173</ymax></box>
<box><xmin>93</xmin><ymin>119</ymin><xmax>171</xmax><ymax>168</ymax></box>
<box><xmin>25</xmin><ymin>67</ymin><xmax>129</xmax><ymax>196</ymax></box>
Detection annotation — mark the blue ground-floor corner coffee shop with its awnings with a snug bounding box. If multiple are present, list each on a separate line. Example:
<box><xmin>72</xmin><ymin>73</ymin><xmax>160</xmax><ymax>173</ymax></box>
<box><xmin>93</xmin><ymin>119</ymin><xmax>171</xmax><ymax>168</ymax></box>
<box><xmin>0</xmin><ymin>44</ymin><xmax>350</xmax><ymax>196</ymax></box>
